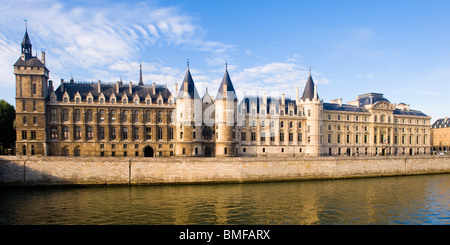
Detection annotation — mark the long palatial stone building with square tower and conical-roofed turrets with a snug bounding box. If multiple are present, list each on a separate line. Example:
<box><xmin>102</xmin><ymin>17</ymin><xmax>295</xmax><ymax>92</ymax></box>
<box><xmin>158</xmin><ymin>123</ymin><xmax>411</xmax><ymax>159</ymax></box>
<box><xmin>14</xmin><ymin>31</ymin><xmax>431</xmax><ymax>157</ymax></box>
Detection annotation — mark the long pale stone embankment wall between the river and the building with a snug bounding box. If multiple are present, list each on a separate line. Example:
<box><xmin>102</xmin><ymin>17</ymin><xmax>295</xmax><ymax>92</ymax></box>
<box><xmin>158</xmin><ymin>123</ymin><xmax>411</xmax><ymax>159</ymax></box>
<box><xmin>0</xmin><ymin>156</ymin><xmax>450</xmax><ymax>185</ymax></box>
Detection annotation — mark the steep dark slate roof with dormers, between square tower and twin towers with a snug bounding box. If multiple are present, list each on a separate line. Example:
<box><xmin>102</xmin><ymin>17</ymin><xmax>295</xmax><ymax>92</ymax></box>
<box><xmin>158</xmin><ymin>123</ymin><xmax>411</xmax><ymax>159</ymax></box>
<box><xmin>54</xmin><ymin>82</ymin><xmax>171</xmax><ymax>103</ymax></box>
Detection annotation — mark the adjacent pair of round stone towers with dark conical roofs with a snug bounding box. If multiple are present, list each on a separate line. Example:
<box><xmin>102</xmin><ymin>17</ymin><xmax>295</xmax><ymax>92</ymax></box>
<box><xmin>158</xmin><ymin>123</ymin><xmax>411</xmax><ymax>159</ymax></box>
<box><xmin>176</xmin><ymin>63</ymin><xmax>239</xmax><ymax>156</ymax></box>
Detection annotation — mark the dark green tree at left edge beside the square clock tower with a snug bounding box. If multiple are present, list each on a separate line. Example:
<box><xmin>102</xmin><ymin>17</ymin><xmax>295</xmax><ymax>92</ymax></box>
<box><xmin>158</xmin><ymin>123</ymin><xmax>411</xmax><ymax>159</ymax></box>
<box><xmin>0</xmin><ymin>99</ymin><xmax>16</xmax><ymax>154</ymax></box>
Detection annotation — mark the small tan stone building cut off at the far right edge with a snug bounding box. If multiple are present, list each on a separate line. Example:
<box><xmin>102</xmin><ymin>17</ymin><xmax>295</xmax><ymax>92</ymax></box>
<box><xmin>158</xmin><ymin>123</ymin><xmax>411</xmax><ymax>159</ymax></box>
<box><xmin>431</xmin><ymin>117</ymin><xmax>450</xmax><ymax>153</ymax></box>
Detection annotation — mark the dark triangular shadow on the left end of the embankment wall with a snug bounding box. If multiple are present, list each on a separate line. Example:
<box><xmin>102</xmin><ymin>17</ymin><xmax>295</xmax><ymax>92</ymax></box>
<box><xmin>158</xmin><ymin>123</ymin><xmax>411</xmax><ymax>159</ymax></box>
<box><xmin>0</xmin><ymin>157</ymin><xmax>74</xmax><ymax>186</ymax></box>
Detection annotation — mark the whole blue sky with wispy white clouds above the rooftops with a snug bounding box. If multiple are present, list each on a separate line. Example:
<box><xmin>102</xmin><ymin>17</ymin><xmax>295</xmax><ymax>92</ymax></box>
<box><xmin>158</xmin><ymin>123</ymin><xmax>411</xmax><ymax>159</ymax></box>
<box><xmin>0</xmin><ymin>0</ymin><xmax>450</xmax><ymax>122</ymax></box>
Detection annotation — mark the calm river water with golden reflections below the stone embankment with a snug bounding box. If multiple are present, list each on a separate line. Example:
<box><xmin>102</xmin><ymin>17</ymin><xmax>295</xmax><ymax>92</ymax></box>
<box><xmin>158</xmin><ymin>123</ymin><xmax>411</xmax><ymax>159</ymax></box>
<box><xmin>0</xmin><ymin>174</ymin><xmax>450</xmax><ymax>225</ymax></box>
